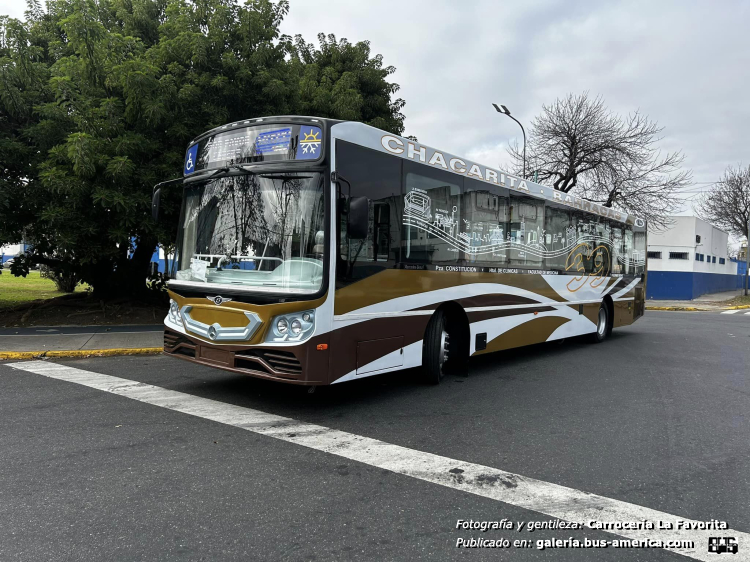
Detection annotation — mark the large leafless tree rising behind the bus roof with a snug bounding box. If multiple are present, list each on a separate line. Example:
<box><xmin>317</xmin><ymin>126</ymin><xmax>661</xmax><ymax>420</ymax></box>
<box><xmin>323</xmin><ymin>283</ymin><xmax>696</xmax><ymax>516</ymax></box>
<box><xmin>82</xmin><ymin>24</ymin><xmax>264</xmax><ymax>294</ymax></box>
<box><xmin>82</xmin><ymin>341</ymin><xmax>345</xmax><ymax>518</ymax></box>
<box><xmin>509</xmin><ymin>92</ymin><xmax>692</xmax><ymax>228</ymax></box>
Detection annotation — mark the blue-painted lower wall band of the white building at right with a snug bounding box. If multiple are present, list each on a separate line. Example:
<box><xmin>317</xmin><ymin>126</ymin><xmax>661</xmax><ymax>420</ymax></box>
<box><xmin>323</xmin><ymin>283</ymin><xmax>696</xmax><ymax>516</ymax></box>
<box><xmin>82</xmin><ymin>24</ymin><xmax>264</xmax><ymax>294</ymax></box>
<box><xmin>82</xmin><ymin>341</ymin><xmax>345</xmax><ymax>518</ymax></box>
<box><xmin>646</xmin><ymin>271</ymin><xmax>742</xmax><ymax>300</ymax></box>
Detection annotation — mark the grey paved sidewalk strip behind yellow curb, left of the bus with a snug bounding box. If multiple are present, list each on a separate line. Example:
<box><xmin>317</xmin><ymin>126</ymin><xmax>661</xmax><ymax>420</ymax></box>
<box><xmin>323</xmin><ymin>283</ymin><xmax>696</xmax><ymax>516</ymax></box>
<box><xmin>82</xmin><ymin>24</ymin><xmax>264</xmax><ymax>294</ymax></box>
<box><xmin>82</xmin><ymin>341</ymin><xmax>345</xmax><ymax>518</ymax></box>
<box><xmin>0</xmin><ymin>324</ymin><xmax>164</xmax><ymax>358</ymax></box>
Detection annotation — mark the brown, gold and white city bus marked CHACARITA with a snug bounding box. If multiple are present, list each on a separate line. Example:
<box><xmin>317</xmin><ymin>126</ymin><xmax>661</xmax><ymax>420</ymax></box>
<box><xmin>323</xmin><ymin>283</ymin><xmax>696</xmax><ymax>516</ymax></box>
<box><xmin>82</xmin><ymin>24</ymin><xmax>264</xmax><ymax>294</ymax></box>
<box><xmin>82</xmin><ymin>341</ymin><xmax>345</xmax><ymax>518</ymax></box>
<box><xmin>152</xmin><ymin>116</ymin><xmax>647</xmax><ymax>386</ymax></box>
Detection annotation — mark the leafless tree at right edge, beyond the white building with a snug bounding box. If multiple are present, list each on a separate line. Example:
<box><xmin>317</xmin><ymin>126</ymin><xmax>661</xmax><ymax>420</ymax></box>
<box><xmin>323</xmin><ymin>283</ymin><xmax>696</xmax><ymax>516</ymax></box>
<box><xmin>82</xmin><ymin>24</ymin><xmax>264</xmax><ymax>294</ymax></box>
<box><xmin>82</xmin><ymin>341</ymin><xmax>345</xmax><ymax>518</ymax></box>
<box><xmin>696</xmin><ymin>165</ymin><xmax>750</xmax><ymax>238</ymax></box>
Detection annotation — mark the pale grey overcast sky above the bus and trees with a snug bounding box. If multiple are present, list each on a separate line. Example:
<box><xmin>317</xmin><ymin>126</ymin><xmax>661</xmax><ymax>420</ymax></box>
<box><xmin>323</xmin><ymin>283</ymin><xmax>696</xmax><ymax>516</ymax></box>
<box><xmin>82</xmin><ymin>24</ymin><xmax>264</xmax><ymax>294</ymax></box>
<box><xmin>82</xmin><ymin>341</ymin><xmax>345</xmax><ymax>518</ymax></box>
<box><xmin>0</xmin><ymin>0</ymin><xmax>750</xmax><ymax>212</ymax></box>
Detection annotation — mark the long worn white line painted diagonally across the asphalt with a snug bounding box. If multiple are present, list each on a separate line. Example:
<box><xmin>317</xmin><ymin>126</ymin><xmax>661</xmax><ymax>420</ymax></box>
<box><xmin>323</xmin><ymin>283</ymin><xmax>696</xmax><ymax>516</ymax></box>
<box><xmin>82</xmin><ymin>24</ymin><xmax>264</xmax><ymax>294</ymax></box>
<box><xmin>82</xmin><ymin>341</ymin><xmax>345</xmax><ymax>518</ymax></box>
<box><xmin>8</xmin><ymin>361</ymin><xmax>750</xmax><ymax>561</ymax></box>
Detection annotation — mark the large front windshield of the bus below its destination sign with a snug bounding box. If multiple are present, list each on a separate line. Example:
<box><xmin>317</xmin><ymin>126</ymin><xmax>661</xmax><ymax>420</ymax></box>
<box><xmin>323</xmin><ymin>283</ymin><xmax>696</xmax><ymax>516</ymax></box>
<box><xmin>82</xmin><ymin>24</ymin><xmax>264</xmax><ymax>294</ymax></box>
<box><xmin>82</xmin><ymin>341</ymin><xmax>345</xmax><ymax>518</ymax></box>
<box><xmin>172</xmin><ymin>172</ymin><xmax>325</xmax><ymax>294</ymax></box>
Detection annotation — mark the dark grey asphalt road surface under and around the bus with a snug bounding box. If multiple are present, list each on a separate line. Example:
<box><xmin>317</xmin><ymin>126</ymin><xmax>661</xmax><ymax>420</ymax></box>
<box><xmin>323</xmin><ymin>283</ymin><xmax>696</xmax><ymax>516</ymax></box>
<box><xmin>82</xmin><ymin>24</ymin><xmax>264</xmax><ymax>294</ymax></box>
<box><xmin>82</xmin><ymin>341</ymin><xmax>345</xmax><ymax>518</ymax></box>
<box><xmin>0</xmin><ymin>312</ymin><xmax>750</xmax><ymax>561</ymax></box>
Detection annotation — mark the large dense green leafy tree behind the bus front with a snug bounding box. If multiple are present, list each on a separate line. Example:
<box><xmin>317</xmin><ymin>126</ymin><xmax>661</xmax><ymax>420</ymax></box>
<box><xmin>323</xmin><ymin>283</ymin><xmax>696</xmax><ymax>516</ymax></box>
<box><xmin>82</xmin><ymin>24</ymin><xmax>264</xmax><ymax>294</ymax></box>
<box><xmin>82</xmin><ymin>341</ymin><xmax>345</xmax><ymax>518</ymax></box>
<box><xmin>0</xmin><ymin>0</ymin><xmax>404</xmax><ymax>297</ymax></box>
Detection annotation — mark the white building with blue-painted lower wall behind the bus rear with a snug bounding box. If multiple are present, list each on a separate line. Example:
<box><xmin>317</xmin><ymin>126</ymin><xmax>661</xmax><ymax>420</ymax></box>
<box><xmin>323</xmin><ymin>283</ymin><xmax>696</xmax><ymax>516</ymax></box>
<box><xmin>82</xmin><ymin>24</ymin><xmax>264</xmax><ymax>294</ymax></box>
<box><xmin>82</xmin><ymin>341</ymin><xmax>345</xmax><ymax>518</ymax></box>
<box><xmin>646</xmin><ymin>217</ymin><xmax>741</xmax><ymax>300</ymax></box>
